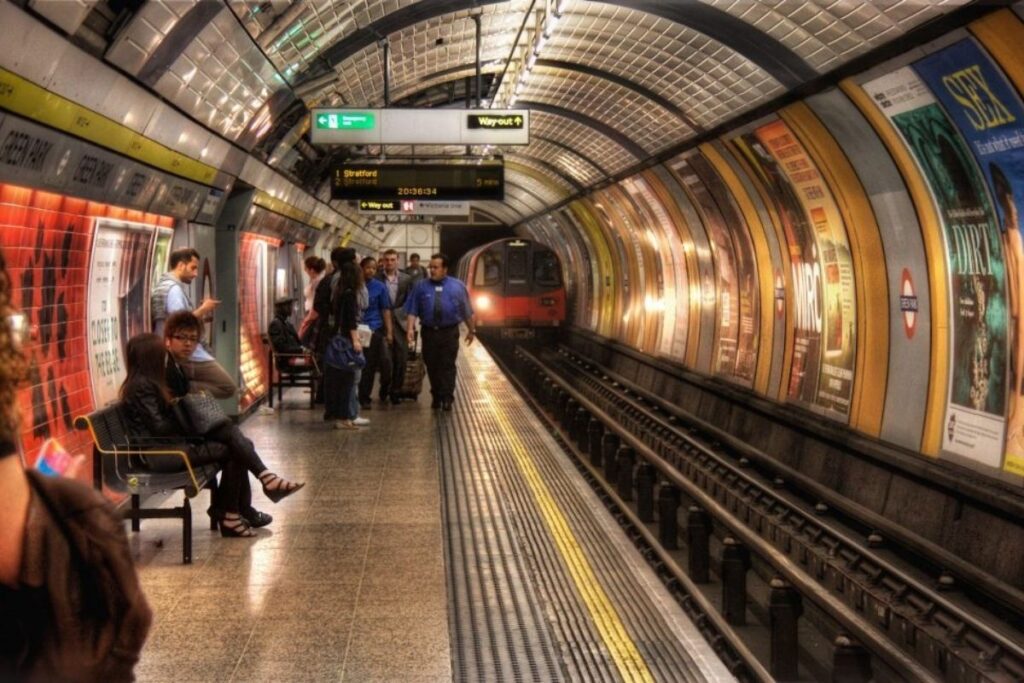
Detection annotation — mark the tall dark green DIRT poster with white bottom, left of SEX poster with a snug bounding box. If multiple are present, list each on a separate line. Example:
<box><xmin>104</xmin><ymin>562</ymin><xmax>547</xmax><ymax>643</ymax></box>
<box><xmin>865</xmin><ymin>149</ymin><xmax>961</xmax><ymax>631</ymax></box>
<box><xmin>862</xmin><ymin>67</ymin><xmax>1009</xmax><ymax>467</ymax></box>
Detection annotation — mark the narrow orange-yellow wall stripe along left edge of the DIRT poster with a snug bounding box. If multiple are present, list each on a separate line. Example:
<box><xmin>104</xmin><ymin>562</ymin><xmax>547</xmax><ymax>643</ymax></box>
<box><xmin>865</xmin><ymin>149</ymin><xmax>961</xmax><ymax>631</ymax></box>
<box><xmin>840</xmin><ymin>79</ymin><xmax>949</xmax><ymax>456</ymax></box>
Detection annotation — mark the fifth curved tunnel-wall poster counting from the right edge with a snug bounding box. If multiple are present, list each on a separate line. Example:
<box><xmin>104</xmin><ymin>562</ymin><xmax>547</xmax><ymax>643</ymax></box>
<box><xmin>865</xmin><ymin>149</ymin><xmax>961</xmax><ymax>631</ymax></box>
<box><xmin>687</xmin><ymin>154</ymin><xmax>758</xmax><ymax>385</ymax></box>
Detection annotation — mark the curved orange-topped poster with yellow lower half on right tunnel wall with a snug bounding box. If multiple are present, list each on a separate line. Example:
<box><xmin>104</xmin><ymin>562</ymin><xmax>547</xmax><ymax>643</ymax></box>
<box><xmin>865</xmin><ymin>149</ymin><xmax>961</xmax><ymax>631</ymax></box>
<box><xmin>756</xmin><ymin>121</ymin><xmax>857</xmax><ymax>416</ymax></box>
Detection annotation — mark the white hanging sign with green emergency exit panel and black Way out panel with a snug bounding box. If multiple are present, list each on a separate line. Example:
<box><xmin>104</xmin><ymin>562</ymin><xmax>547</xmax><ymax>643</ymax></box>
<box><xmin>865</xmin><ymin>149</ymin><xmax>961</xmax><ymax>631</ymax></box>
<box><xmin>309</xmin><ymin>109</ymin><xmax>529</xmax><ymax>145</ymax></box>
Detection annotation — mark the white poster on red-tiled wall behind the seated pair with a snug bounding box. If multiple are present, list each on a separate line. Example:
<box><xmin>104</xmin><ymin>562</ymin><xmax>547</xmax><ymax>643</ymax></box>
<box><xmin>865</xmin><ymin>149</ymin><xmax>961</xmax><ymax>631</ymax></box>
<box><xmin>87</xmin><ymin>218</ymin><xmax>156</xmax><ymax>407</ymax></box>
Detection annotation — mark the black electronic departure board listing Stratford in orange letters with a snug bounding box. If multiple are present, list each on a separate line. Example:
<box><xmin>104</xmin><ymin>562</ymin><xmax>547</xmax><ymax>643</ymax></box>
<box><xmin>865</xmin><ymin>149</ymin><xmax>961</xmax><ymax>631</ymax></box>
<box><xmin>331</xmin><ymin>164</ymin><xmax>505</xmax><ymax>201</ymax></box>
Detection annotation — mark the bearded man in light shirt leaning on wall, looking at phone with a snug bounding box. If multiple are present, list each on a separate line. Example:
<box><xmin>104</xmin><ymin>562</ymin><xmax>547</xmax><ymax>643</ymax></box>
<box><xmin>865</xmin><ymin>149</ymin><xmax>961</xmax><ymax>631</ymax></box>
<box><xmin>150</xmin><ymin>247</ymin><xmax>239</xmax><ymax>398</ymax></box>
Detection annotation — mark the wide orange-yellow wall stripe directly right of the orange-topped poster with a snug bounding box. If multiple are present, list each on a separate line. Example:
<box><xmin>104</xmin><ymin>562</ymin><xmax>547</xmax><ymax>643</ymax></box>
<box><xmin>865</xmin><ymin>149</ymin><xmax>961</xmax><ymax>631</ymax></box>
<box><xmin>780</xmin><ymin>102</ymin><xmax>889</xmax><ymax>436</ymax></box>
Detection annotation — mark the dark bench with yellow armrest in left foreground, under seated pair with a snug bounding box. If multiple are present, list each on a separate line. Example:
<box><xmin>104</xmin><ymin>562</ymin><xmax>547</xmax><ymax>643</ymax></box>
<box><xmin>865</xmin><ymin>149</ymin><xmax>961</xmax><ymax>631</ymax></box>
<box><xmin>75</xmin><ymin>403</ymin><xmax>219</xmax><ymax>564</ymax></box>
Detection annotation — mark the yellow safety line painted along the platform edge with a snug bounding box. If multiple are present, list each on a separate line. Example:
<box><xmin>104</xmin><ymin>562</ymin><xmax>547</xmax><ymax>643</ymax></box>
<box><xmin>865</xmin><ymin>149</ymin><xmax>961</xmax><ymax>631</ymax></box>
<box><xmin>481</xmin><ymin>366</ymin><xmax>654</xmax><ymax>683</ymax></box>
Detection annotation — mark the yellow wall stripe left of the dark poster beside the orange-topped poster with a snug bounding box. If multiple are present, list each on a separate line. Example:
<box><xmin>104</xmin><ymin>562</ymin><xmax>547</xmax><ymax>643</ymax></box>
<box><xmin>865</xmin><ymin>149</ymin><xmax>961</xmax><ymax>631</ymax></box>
<box><xmin>700</xmin><ymin>143</ymin><xmax>775</xmax><ymax>394</ymax></box>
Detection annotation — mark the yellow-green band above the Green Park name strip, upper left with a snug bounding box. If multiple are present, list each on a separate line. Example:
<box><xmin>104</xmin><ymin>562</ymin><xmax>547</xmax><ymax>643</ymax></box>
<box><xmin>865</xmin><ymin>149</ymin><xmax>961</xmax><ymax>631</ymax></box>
<box><xmin>0</xmin><ymin>69</ymin><xmax>217</xmax><ymax>185</ymax></box>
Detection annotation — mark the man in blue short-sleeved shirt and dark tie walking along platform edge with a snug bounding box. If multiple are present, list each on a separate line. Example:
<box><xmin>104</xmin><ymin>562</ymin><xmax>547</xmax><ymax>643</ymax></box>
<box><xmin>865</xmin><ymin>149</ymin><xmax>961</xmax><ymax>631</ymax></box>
<box><xmin>406</xmin><ymin>254</ymin><xmax>476</xmax><ymax>411</ymax></box>
